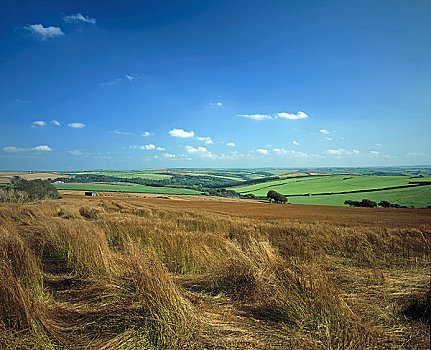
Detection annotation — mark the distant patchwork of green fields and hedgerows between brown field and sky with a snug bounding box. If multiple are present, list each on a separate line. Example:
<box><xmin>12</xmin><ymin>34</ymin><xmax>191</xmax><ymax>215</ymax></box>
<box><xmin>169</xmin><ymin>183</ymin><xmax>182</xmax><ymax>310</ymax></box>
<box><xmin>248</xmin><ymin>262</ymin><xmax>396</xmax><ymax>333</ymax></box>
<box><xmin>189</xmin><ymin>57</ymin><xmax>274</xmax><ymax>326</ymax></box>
<box><xmin>0</xmin><ymin>168</ymin><xmax>431</xmax><ymax>208</ymax></box>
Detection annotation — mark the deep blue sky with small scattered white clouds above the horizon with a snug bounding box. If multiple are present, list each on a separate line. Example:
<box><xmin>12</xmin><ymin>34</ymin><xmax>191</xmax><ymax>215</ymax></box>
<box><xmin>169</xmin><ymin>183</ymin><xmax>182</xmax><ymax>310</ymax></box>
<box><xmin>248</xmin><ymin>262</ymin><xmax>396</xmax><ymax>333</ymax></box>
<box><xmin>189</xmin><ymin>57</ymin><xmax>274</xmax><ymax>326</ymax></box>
<box><xmin>0</xmin><ymin>0</ymin><xmax>431</xmax><ymax>170</ymax></box>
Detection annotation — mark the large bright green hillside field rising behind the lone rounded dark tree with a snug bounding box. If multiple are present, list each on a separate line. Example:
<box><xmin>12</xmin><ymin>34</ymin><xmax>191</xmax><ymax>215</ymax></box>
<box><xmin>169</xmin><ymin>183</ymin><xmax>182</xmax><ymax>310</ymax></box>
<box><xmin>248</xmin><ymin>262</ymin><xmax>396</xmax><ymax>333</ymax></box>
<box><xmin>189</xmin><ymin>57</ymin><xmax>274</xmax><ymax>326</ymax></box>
<box><xmin>233</xmin><ymin>175</ymin><xmax>431</xmax><ymax>196</ymax></box>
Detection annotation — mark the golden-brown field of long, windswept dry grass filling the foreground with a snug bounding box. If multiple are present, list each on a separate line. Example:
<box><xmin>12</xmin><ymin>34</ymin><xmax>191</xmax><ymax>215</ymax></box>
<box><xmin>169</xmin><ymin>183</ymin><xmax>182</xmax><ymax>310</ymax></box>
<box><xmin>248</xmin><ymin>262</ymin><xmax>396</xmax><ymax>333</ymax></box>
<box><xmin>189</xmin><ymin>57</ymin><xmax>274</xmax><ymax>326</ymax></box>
<box><xmin>0</xmin><ymin>198</ymin><xmax>431</xmax><ymax>349</ymax></box>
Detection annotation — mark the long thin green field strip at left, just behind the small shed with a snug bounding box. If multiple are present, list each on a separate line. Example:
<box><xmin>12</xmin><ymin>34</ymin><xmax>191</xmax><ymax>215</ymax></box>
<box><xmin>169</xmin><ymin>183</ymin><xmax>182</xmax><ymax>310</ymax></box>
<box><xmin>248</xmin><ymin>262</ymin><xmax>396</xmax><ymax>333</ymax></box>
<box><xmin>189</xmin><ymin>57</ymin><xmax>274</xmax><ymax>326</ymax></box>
<box><xmin>54</xmin><ymin>183</ymin><xmax>201</xmax><ymax>195</ymax></box>
